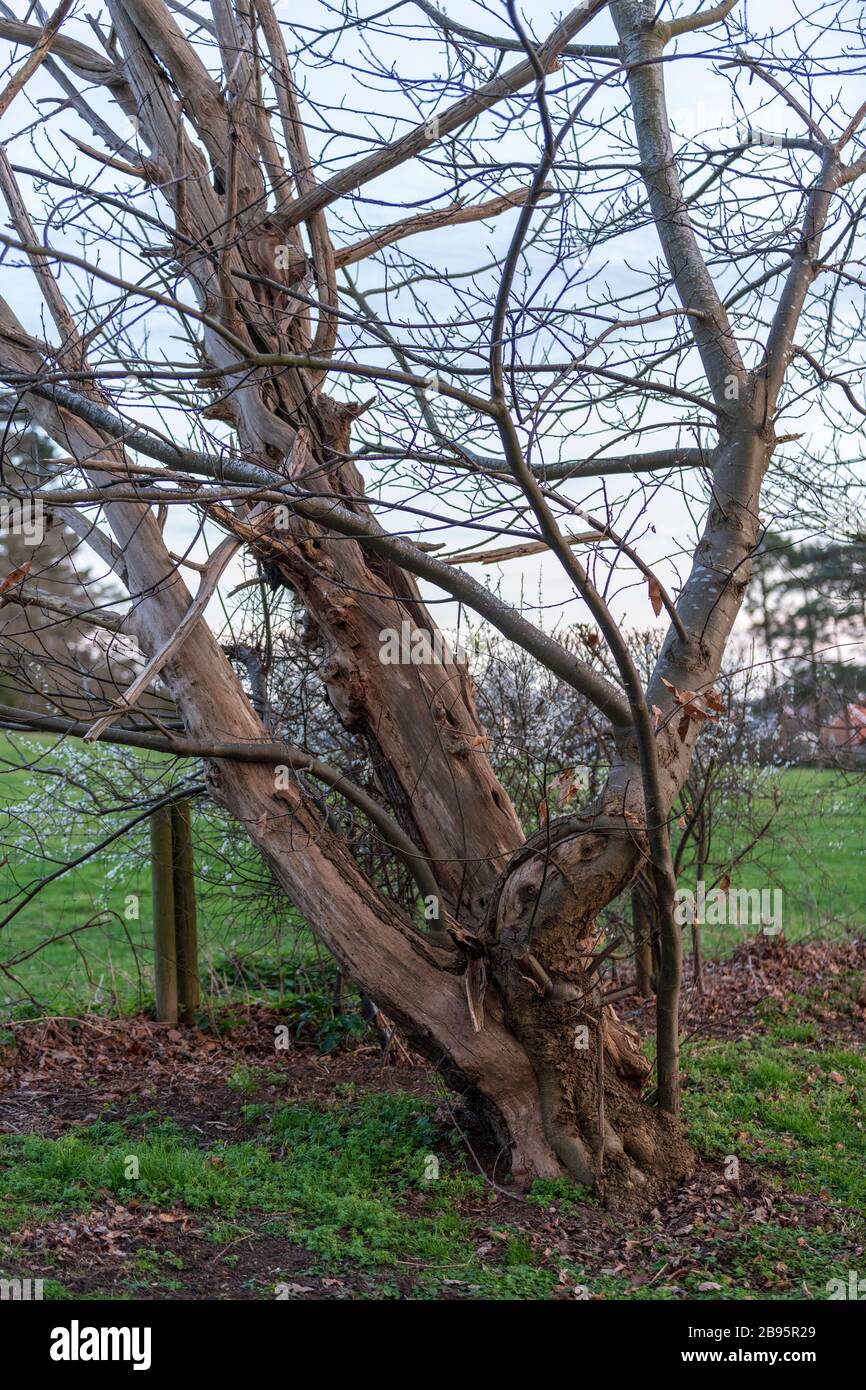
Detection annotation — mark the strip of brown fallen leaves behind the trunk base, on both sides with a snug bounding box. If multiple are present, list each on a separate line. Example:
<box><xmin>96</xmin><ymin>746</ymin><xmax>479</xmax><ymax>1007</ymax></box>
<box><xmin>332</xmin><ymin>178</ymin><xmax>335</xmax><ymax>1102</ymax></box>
<box><xmin>0</xmin><ymin>938</ymin><xmax>866</xmax><ymax>1139</ymax></box>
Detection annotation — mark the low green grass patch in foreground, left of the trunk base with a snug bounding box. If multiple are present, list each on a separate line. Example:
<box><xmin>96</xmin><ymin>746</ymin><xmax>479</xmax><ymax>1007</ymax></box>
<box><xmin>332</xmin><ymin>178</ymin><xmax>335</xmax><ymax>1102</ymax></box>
<box><xmin>0</xmin><ymin>1095</ymin><xmax>569</xmax><ymax>1298</ymax></box>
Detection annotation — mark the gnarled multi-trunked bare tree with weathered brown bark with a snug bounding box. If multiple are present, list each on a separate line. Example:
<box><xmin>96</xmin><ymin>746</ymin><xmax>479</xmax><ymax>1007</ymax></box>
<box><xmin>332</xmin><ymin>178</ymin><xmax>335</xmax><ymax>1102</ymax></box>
<box><xmin>0</xmin><ymin>0</ymin><xmax>866</xmax><ymax>1190</ymax></box>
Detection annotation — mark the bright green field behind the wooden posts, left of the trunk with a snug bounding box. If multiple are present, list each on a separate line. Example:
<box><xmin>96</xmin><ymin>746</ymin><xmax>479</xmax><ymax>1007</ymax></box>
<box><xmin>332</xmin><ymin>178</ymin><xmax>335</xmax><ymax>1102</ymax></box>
<box><xmin>0</xmin><ymin>734</ymin><xmax>316</xmax><ymax>1015</ymax></box>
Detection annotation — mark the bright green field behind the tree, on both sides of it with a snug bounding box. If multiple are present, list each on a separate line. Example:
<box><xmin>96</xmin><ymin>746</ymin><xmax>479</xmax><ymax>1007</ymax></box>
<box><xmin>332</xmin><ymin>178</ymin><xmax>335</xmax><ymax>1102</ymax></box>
<box><xmin>0</xmin><ymin>735</ymin><xmax>866</xmax><ymax>1013</ymax></box>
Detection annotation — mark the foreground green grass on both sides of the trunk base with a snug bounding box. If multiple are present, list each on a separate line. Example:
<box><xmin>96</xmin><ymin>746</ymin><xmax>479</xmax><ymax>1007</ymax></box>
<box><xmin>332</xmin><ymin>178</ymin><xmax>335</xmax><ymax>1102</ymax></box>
<box><xmin>0</xmin><ymin>974</ymin><xmax>866</xmax><ymax>1301</ymax></box>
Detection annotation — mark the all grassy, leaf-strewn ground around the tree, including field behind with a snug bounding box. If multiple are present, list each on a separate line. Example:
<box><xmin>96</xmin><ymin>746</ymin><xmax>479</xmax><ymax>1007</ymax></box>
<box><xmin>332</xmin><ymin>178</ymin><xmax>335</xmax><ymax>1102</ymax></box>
<box><xmin>0</xmin><ymin>717</ymin><xmax>866</xmax><ymax>1301</ymax></box>
